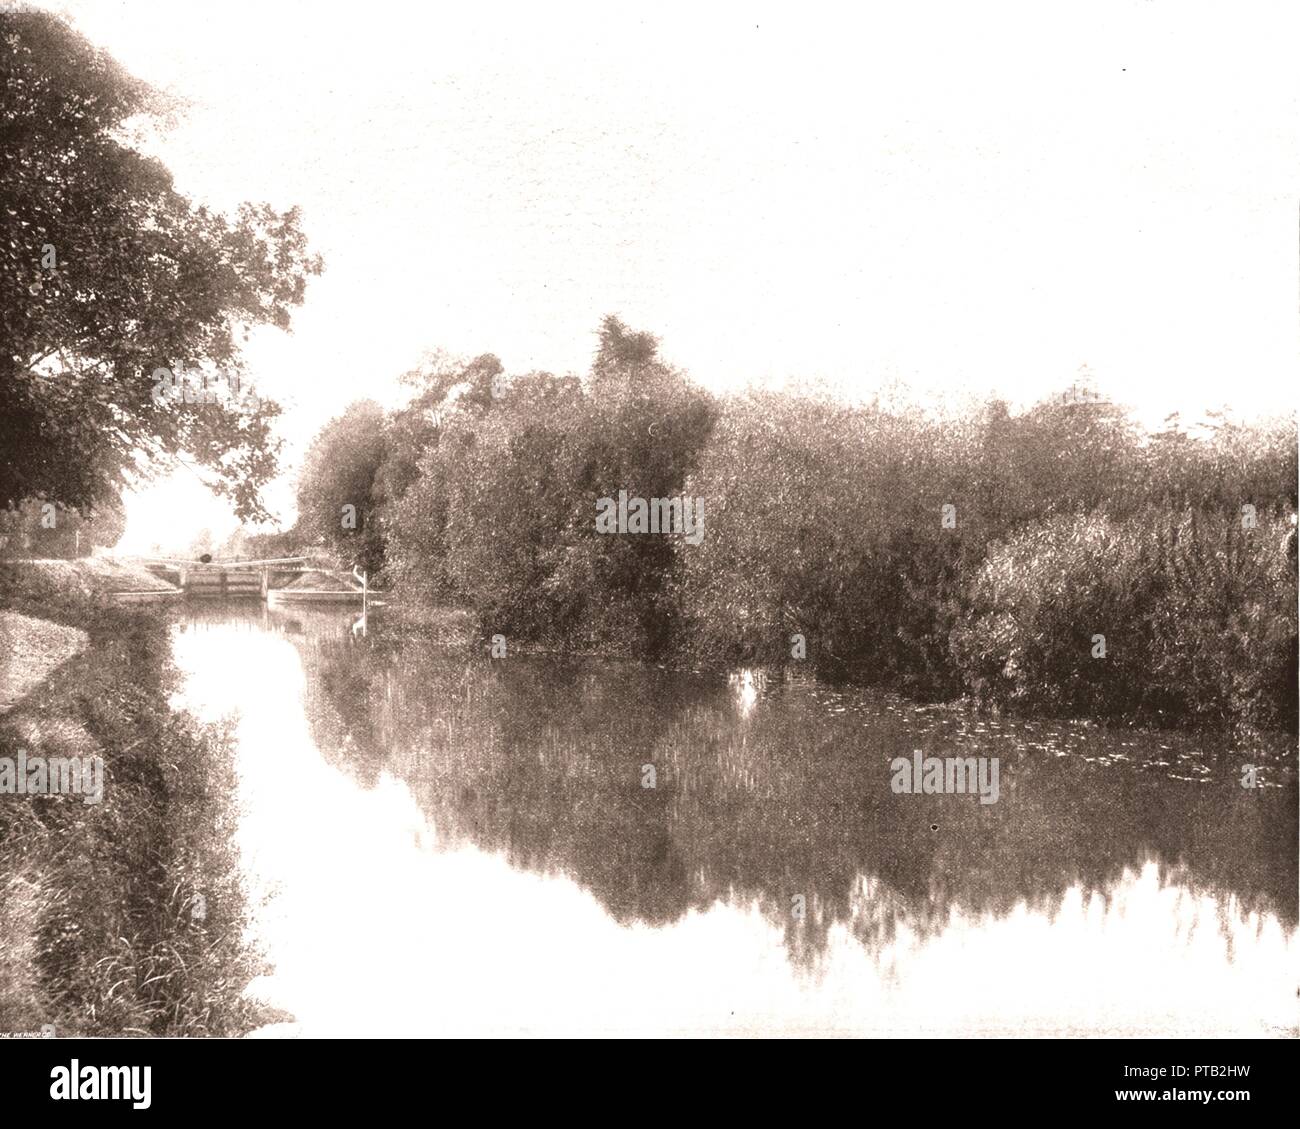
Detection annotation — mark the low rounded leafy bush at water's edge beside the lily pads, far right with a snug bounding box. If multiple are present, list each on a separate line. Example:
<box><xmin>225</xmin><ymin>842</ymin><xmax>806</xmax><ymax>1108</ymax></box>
<box><xmin>952</xmin><ymin>510</ymin><xmax>1296</xmax><ymax>724</ymax></box>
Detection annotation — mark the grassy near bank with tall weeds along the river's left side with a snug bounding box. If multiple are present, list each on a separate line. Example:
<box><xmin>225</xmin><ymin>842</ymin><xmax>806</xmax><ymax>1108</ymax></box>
<box><xmin>0</xmin><ymin>584</ymin><xmax>269</xmax><ymax>1035</ymax></box>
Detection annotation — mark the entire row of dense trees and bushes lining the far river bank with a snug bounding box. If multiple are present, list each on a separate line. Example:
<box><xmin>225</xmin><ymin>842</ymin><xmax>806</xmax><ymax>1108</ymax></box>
<box><xmin>298</xmin><ymin>317</ymin><xmax>1296</xmax><ymax>727</ymax></box>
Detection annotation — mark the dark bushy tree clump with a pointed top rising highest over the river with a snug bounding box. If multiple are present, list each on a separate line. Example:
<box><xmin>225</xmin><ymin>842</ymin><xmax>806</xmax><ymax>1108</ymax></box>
<box><xmin>384</xmin><ymin>319</ymin><xmax>712</xmax><ymax>654</ymax></box>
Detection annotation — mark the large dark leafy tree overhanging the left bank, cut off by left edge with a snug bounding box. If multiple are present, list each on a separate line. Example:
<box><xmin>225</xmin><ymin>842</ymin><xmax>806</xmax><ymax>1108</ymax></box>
<box><xmin>0</xmin><ymin>12</ymin><xmax>320</xmax><ymax>519</ymax></box>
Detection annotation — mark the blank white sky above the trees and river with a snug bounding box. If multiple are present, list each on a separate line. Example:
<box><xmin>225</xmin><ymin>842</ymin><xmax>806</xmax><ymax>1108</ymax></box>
<box><xmin>35</xmin><ymin>0</ymin><xmax>1300</xmax><ymax>544</ymax></box>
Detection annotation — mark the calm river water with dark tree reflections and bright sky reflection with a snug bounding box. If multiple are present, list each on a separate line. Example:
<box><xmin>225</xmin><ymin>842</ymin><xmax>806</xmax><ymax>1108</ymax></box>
<box><xmin>173</xmin><ymin>604</ymin><xmax>1300</xmax><ymax>1037</ymax></box>
